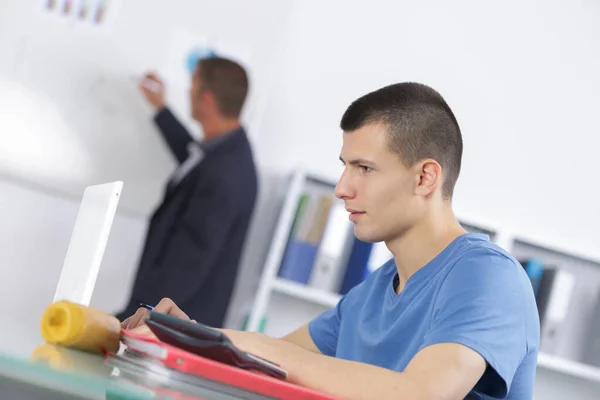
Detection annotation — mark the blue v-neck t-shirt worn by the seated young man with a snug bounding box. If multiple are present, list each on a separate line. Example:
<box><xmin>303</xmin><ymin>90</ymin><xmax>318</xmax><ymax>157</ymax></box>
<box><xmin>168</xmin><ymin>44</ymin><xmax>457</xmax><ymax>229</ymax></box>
<box><xmin>309</xmin><ymin>233</ymin><xmax>540</xmax><ymax>400</ymax></box>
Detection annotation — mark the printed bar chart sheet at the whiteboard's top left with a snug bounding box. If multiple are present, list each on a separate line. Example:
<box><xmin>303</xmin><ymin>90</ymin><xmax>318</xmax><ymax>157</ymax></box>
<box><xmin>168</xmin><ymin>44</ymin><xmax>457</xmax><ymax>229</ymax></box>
<box><xmin>39</xmin><ymin>0</ymin><xmax>121</xmax><ymax>33</ymax></box>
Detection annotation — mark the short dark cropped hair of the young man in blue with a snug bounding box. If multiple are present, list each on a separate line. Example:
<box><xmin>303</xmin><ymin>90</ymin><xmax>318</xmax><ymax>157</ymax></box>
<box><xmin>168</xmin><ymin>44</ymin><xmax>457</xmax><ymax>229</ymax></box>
<box><xmin>340</xmin><ymin>82</ymin><xmax>463</xmax><ymax>199</ymax></box>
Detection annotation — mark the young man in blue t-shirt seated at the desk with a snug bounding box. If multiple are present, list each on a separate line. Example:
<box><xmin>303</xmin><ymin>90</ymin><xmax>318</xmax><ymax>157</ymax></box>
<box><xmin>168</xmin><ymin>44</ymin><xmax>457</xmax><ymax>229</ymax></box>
<box><xmin>124</xmin><ymin>83</ymin><xmax>539</xmax><ymax>400</ymax></box>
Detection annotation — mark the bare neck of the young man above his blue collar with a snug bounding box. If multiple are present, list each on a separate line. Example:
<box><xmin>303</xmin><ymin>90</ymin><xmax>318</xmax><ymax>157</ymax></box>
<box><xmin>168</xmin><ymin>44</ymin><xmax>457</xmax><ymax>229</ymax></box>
<box><xmin>386</xmin><ymin>207</ymin><xmax>467</xmax><ymax>293</ymax></box>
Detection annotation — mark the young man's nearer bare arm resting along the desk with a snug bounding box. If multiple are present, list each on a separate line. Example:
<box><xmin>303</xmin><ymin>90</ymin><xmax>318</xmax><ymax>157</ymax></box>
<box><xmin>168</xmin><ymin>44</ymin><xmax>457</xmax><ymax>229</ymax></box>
<box><xmin>224</xmin><ymin>330</ymin><xmax>486</xmax><ymax>400</ymax></box>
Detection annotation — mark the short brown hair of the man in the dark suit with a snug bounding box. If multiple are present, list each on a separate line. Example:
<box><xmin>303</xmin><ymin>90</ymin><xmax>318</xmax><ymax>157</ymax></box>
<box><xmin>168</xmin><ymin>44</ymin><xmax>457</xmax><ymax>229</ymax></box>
<box><xmin>198</xmin><ymin>57</ymin><xmax>248</xmax><ymax>118</ymax></box>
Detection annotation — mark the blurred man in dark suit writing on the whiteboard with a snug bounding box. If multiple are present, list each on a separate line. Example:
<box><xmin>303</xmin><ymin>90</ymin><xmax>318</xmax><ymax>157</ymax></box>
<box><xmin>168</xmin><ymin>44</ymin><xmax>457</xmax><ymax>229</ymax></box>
<box><xmin>117</xmin><ymin>57</ymin><xmax>258</xmax><ymax>327</ymax></box>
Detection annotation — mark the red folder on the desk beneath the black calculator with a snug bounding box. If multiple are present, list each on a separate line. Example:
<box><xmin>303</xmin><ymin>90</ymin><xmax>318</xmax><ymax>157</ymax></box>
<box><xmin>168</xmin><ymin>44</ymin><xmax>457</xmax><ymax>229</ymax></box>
<box><xmin>121</xmin><ymin>330</ymin><xmax>336</xmax><ymax>400</ymax></box>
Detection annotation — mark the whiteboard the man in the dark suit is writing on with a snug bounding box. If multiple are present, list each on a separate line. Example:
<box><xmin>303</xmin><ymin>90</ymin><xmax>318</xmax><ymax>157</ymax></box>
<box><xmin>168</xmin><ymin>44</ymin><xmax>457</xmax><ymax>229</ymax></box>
<box><xmin>0</xmin><ymin>0</ymin><xmax>291</xmax><ymax>214</ymax></box>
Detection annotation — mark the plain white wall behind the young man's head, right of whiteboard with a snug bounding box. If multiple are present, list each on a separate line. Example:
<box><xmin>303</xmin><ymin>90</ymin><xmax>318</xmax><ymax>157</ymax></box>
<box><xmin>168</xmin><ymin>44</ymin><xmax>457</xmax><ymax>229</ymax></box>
<box><xmin>247</xmin><ymin>0</ymin><xmax>600</xmax><ymax>399</ymax></box>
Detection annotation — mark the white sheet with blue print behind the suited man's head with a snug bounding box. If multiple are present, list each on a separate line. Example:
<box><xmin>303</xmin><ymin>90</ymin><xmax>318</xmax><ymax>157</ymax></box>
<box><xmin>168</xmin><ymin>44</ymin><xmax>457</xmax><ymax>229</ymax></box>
<box><xmin>159</xmin><ymin>29</ymin><xmax>251</xmax><ymax>141</ymax></box>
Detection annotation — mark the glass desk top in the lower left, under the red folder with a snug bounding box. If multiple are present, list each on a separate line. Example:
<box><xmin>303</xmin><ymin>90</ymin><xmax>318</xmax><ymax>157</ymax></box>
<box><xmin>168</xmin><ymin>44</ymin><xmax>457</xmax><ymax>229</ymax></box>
<box><xmin>0</xmin><ymin>323</ymin><xmax>276</xmax><ymax>400</ymax></box>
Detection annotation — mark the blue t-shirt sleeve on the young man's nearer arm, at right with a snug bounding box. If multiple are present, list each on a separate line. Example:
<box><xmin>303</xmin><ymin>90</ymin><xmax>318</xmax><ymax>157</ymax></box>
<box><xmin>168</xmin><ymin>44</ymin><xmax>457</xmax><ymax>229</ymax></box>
<box><xmin>422</xmin><ymin>250</ymin><xmax>531</xmax><ymax>398</ymax></box>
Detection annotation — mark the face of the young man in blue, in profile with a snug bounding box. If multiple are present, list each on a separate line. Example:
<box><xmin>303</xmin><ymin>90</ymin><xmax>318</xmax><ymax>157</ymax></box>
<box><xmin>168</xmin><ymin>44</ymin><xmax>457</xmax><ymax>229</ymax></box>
<box><xmin>335</xmin><ymin>124</ymin><xmax>422</xmax><ymax>242</ymax></box>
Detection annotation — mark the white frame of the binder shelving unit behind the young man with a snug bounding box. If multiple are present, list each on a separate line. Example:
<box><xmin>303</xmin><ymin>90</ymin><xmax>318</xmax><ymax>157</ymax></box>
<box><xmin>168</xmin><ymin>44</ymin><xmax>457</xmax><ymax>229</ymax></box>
<box><xmin>248</xmin><ymin>171</ymin><xmax>600</xmax><ymax>383</ymax></box>
